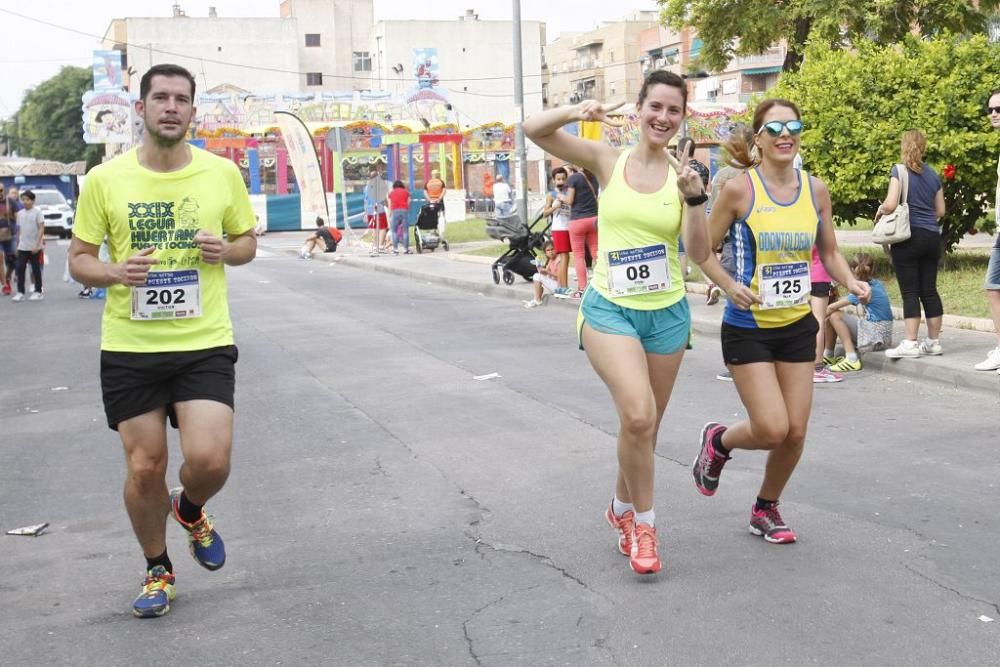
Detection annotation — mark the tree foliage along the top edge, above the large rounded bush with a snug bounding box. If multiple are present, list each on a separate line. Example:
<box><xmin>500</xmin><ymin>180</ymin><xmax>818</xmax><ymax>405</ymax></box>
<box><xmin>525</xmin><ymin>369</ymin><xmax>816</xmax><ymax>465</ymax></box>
<box><xmin>657</xmin><ymin>0</ymin><xmax>1000</xmax><ymax>71</ymax></box>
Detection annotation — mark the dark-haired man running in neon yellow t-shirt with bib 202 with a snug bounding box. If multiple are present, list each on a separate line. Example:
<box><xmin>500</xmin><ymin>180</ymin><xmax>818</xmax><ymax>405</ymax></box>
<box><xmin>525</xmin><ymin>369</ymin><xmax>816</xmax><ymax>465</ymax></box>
<box><xmin>69</xmin><ymin>64</ymin><xmax>257</xmax><ymax>618</ymax></box>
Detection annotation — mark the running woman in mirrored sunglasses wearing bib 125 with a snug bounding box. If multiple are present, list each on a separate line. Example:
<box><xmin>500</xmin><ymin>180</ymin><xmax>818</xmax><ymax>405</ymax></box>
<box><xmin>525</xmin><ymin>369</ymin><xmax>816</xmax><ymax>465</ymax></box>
<box><xmin>685</xmin><ymin>99</ymin><xmax>869</xmax><ymax>544</ymax></box>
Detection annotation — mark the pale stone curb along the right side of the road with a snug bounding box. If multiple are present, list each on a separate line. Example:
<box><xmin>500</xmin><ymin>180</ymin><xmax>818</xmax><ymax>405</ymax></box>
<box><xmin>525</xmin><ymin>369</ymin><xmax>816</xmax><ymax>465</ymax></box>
<box><xmin>308</xmin><ymin>250</ymin><xmax>1000</xmax><ymax>396</ymax></box>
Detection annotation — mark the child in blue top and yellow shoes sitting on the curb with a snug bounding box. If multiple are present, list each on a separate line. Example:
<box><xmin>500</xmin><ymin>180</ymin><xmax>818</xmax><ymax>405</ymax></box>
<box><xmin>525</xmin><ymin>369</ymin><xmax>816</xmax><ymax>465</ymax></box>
<box><xmin>823</xmin><ymin>252</ymin><xmax>892</xmax><ymax>373</ymax></box>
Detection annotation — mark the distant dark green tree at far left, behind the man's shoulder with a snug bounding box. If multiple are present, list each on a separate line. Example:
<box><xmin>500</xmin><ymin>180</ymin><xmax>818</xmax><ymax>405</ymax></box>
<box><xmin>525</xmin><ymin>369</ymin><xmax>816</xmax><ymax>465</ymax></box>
<box><xmin>12</xmin><ymin>66</ymin><xmax>104</xmax><ymax>163</ymax></box>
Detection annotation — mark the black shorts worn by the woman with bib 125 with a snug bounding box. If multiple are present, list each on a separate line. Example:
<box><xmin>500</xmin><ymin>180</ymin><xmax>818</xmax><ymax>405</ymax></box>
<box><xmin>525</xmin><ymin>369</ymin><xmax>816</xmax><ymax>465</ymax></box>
<box><xmin>722</xmin><ymin>313</ymin><xmax>819</xmax><ymax>366</ymax></box>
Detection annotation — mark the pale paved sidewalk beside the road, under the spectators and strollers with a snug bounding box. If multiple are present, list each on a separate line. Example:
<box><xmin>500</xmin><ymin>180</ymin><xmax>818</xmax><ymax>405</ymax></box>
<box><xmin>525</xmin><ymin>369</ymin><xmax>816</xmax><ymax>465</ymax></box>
<box><xmin>260</xmin><ymin>234</ymin><xmax>1000</xmax><ymax>396</ymax></box>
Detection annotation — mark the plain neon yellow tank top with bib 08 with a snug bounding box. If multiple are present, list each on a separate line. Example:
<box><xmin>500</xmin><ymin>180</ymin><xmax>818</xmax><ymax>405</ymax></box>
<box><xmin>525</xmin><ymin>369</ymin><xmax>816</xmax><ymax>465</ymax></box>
<box><xmin>591</xmin><ymin>149</ymin><xmax>684</xmax><ymax>310</ymax></box>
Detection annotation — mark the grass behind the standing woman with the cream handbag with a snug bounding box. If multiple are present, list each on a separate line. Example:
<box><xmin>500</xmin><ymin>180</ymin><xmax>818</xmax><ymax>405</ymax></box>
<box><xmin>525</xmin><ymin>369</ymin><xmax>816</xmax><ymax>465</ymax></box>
<box><xmin>841</xmin><ymin>245</ymin><xmax>990</xmax><ymax>317</ymax></box>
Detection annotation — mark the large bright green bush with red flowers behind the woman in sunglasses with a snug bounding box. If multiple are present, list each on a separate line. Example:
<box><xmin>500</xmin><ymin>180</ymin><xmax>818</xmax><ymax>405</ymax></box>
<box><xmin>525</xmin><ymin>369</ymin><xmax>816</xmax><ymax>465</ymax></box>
<box><xmin>768</xmin><ymin>35</ymin><xmax>1000</xmax><ymax>250</ymax></box>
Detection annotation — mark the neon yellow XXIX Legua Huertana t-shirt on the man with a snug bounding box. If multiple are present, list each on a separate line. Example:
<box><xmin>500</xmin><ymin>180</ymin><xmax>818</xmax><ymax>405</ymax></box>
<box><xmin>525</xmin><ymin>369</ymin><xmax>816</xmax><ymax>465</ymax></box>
<box><xmin>73</xmin><ymin>146</ymin><xmax>255</xmax><ymax>352</ymax></box>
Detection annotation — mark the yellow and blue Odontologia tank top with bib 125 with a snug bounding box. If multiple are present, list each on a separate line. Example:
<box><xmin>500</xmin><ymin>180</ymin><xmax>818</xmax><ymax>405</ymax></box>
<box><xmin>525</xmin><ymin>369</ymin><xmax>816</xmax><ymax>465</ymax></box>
<box><xmin>722</xmin><ymin>168</ymin><xmax>820</xmax><ymax>329</ymax></box>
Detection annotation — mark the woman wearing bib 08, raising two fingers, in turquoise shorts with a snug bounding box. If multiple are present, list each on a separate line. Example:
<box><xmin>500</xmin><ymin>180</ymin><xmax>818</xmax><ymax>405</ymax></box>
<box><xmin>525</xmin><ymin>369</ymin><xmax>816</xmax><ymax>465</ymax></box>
<box><xmin>524</xmin><ymin>70</ymin><xmax>707</xmax><ymax>574</ymax></box>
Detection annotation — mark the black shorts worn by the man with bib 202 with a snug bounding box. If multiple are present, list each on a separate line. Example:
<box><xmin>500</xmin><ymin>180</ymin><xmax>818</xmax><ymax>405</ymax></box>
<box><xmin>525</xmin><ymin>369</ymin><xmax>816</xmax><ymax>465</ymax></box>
<box><xmin>101</xmin><ymin>345</ymin><xmax>239</xmax><ymax>431</ymax></box>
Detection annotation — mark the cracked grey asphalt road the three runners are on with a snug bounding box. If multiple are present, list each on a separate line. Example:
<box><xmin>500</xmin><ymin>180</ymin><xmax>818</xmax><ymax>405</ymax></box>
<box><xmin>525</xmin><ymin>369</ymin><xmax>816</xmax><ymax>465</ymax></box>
<box><xmin>0</xmin><ymin>246</ymin><xmax>1000</xmax><ymax>666</ymax></box>
